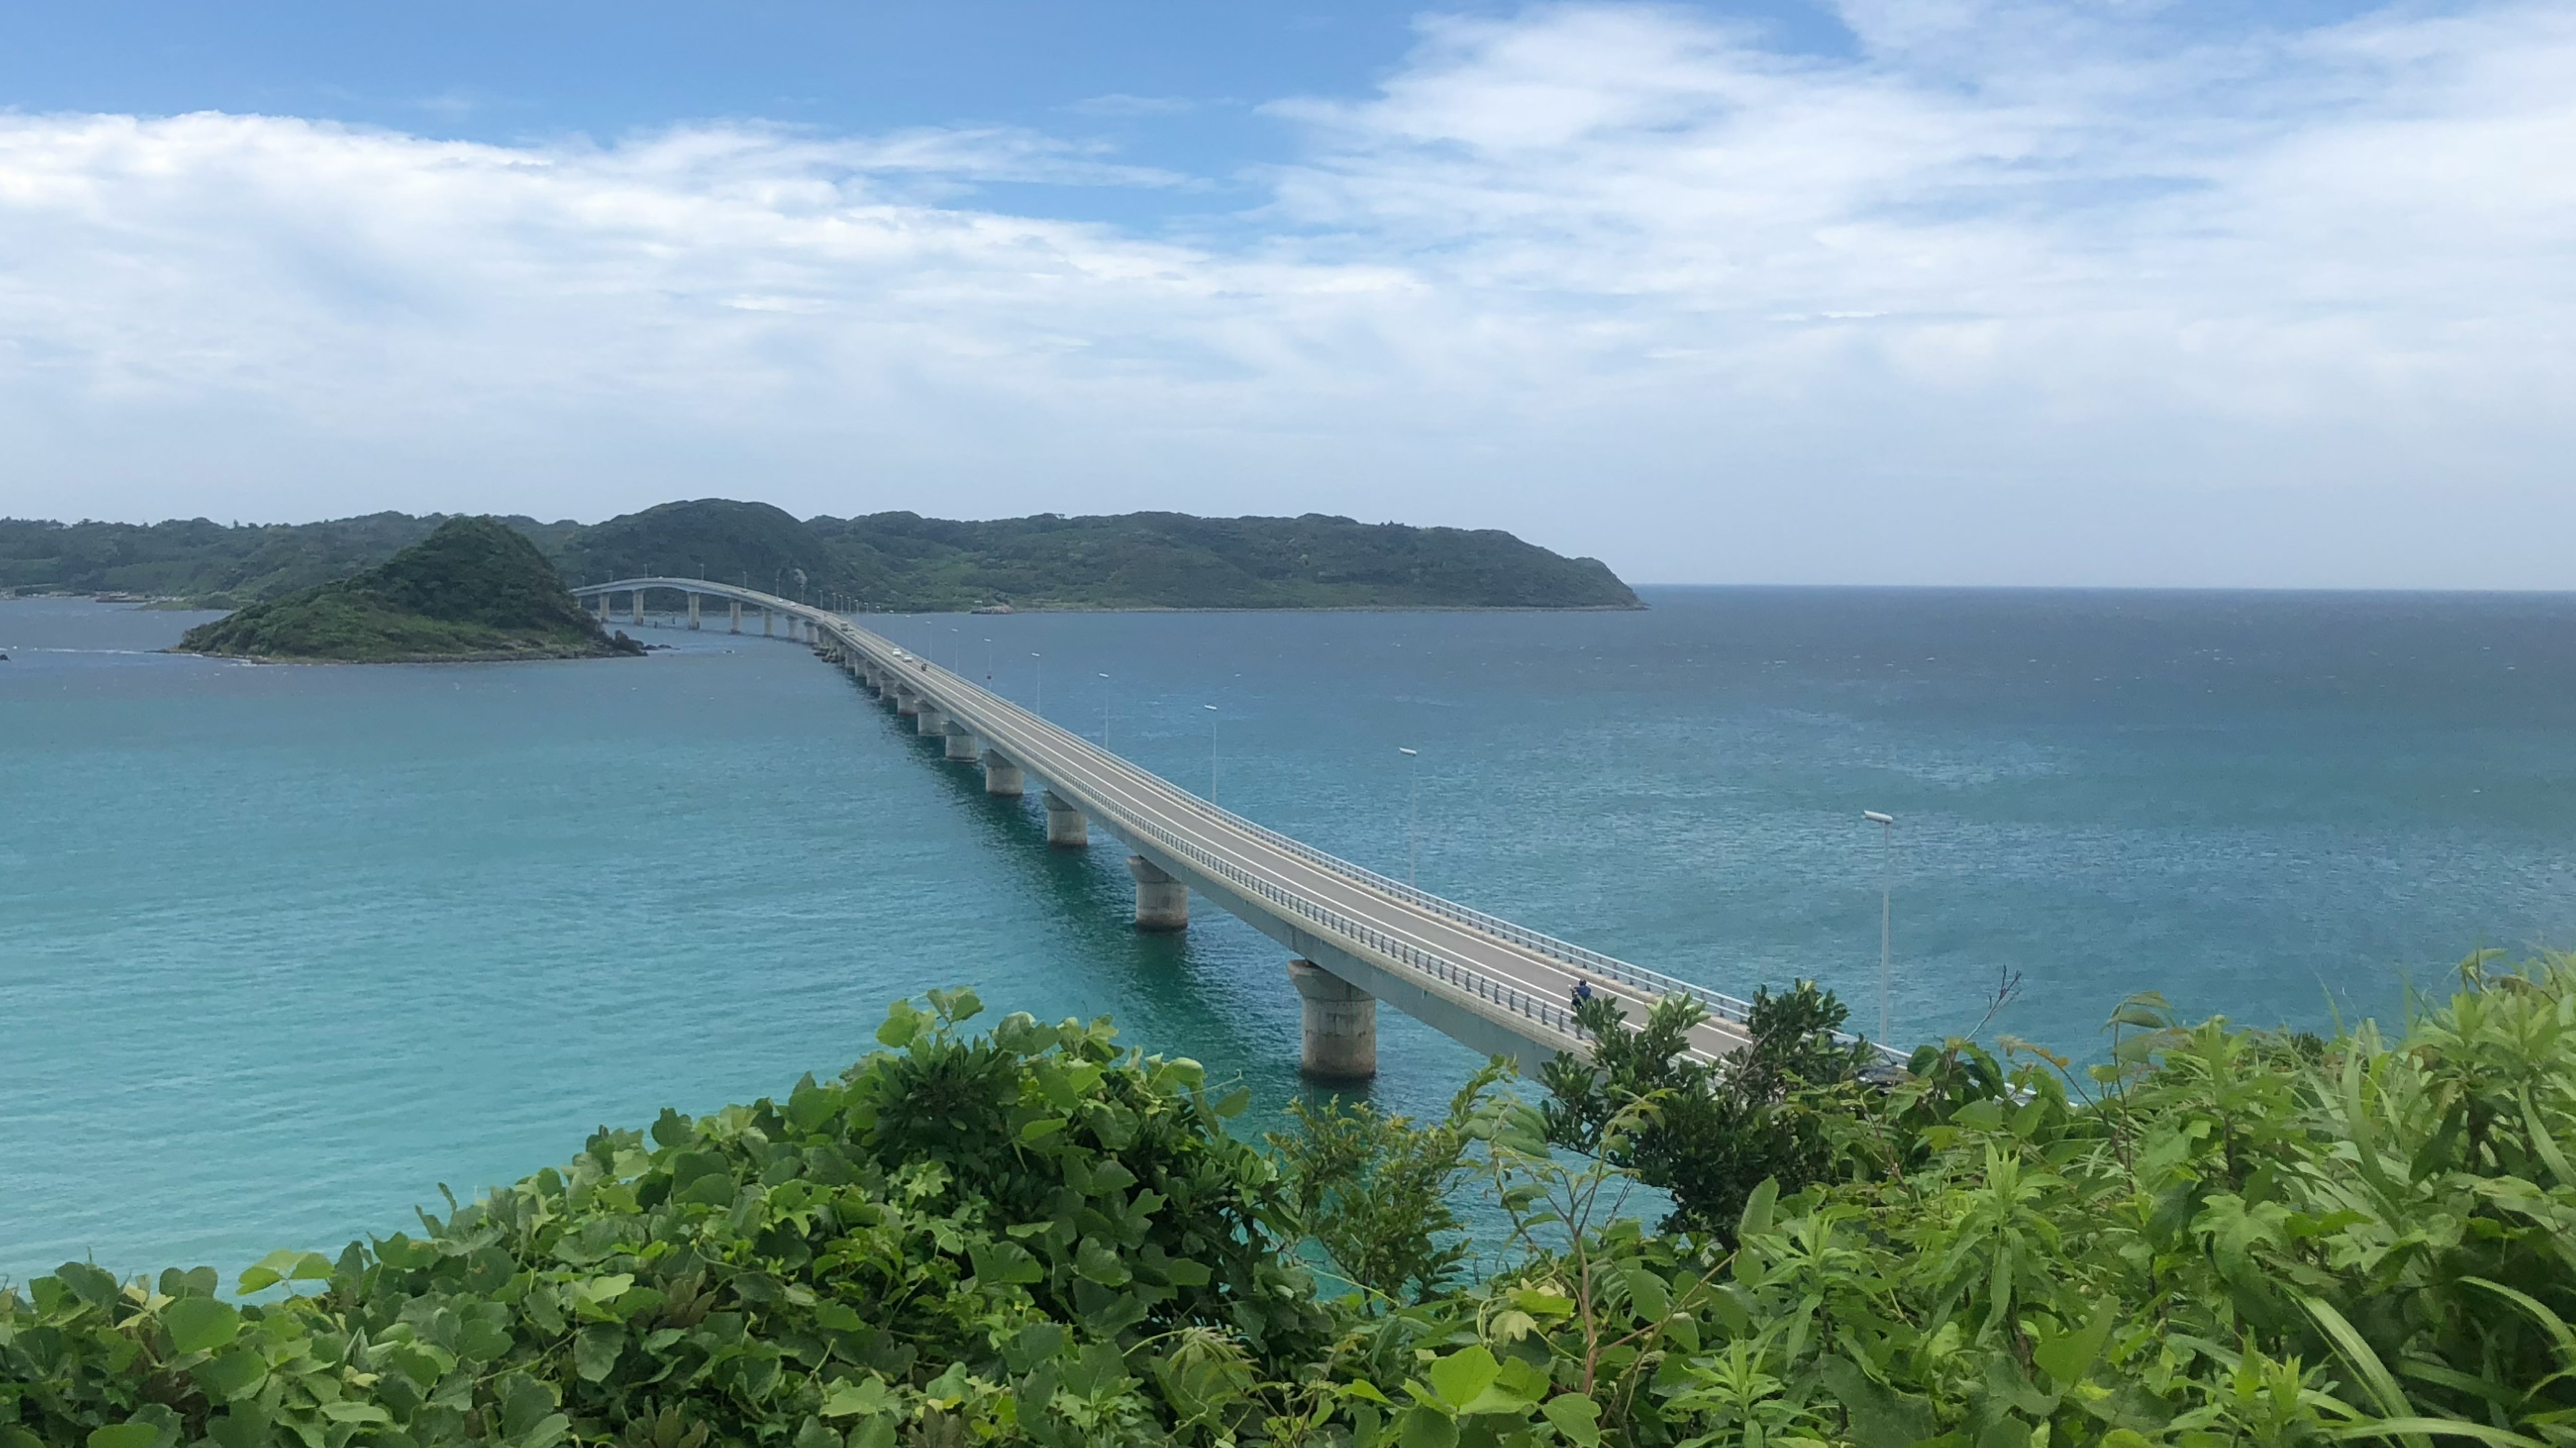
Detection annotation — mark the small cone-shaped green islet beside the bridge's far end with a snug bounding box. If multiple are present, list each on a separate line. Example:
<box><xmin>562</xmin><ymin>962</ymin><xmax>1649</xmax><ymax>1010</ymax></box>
<box><xmin>178</xmin><ymin>518</ymin><xmax>641</xmax><ymax>662</ymax></box>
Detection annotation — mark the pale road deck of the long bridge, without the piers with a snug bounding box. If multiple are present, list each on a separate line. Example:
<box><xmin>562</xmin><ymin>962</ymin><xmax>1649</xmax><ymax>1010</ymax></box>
<box><xmin>574</xmin><ymin>577</ymin><xmax>1875</xmax><ymax>1064</ymax></box>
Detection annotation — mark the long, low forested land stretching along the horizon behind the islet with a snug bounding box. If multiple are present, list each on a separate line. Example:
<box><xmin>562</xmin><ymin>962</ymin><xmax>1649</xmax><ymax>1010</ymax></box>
<box><xmin>0</xmin><ymin>497</ymin><xmax>1638</xmax><ymax>610</ymax></box>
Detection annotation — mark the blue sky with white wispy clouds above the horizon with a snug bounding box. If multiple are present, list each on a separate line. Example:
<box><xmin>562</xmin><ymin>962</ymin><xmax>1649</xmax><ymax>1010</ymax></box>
<box><xmin>0</xmin><ymin>0</ymin><xmax>2576</xmax><ymax>588</ymax></box>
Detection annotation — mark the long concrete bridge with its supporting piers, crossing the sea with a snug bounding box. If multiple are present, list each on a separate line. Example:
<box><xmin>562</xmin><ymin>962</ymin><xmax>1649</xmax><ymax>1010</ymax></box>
<box><xmin>572</xmin><ymin>577</ymin><xmax>1885</xmax><ymax>1080</ymax></box>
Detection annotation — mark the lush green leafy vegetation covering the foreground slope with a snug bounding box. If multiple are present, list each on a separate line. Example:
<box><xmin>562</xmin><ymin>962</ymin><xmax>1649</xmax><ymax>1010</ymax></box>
<box><xmin>0</xmin><ymin>956</ymin><xmax>2576</xmax><ymax>1448</ymax></box>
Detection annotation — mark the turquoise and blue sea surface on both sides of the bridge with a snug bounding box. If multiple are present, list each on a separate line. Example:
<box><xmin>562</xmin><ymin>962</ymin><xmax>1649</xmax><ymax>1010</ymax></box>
<box><xmin>0</xmin><ymin>590</ymin><xmax>2576</xmax><ymax>1278</ymax></box>
